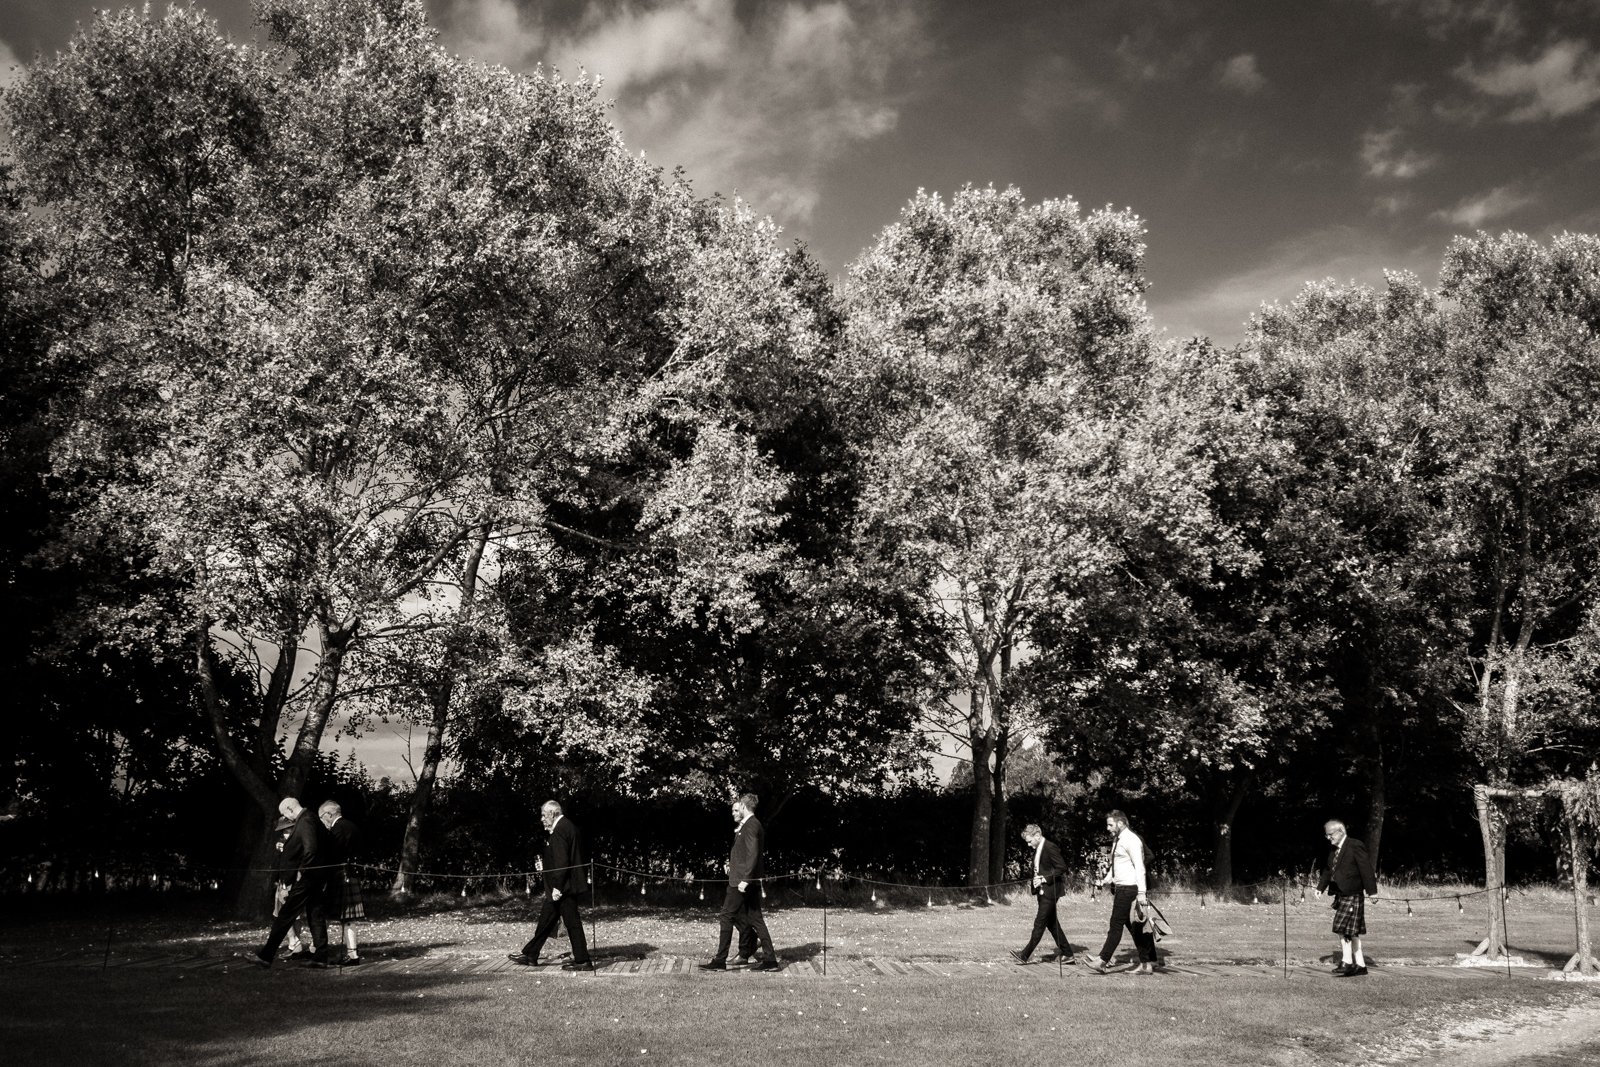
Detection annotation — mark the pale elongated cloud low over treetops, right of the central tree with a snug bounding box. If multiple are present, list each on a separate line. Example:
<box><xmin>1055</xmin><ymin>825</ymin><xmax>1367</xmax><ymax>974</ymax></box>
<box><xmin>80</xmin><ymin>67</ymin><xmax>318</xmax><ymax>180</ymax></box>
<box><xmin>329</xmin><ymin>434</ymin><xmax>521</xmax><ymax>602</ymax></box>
<box><xmin>1149</xmin><ymin>227</ymin><xmax>1442</xmax><ymax>344</ymax></box>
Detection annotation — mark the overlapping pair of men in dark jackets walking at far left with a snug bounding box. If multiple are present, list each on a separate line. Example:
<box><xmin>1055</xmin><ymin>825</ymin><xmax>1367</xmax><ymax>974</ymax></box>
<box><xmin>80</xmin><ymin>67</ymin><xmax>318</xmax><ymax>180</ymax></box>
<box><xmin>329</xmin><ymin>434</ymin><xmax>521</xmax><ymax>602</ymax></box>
<box><xmin>251</xmin><ymin>797</ymin><xmax>366</xmax><ymax>968</ymax></box>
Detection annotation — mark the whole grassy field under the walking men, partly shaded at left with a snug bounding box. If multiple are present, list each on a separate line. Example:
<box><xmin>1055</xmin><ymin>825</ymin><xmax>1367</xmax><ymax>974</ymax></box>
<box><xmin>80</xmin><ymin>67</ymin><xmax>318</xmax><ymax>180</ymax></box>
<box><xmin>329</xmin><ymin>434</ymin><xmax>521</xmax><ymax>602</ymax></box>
<box><xmin>0</xmin><ymin>889</ymin><xmax>1600</xmax><ymax>1065</ymax></box>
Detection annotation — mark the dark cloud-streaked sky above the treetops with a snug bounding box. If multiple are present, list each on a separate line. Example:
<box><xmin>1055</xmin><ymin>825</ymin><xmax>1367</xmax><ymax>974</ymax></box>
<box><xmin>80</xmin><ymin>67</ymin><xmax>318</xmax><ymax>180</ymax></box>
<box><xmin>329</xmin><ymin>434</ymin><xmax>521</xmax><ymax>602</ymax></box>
<box><xmin>0</xmin><ymin>0</ymin><xmax>1600</xmax><ymax>771</ymax></box>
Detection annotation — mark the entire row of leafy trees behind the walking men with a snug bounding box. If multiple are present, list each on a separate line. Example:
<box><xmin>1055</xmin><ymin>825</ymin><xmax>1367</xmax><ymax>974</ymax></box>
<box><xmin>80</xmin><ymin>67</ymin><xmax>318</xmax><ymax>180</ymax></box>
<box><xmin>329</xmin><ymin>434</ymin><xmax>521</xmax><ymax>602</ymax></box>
<box><xmin>0</xmin><ymin>0</ymin><xmax>1600</xmax><ymax>959</ymax></box>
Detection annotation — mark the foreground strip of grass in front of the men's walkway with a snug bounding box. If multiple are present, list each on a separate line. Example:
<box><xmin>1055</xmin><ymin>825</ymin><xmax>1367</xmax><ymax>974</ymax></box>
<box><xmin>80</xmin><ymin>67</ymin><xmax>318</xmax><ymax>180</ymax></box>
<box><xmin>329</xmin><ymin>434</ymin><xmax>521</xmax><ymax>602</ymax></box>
<box><xmin>0</xmin><ymin>968</ymin><xmax>1600</xmax><ymax>1067</ymax></box>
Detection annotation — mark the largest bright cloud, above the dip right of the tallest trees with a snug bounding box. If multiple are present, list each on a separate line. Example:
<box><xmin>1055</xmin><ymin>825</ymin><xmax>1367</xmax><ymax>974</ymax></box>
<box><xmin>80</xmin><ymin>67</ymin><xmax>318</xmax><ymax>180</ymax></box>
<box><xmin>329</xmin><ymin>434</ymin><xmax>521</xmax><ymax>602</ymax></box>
<box><xmin>446</xmin><ymin>0</ymin><xmax>926</xmax><ymax>226</ymax></box>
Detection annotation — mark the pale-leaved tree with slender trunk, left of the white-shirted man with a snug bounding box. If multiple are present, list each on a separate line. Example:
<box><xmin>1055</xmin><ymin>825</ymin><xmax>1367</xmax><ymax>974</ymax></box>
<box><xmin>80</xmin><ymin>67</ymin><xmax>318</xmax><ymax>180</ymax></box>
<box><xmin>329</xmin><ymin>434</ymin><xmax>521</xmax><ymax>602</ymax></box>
<box><xmin>840</xmin><ymin>187</ymin><xmax>1205</xmax><ymax>885</ymax></box>
